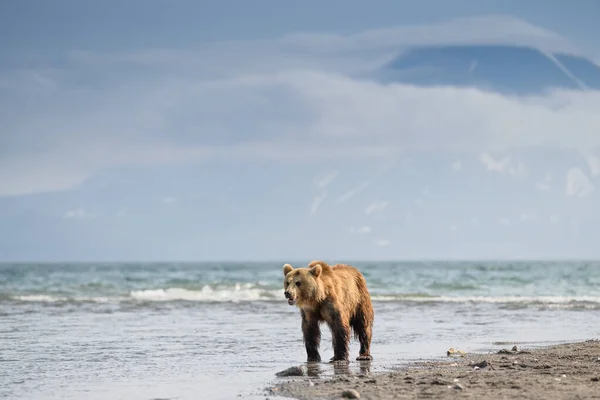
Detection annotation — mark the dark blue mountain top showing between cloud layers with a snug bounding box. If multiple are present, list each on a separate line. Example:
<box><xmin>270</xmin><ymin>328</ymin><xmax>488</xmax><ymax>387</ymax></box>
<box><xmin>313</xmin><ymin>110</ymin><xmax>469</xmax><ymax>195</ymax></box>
<box><xmin>378</xmin><ymin>45</ymin><xmax>600</xmax><ymax>94</ymax></box>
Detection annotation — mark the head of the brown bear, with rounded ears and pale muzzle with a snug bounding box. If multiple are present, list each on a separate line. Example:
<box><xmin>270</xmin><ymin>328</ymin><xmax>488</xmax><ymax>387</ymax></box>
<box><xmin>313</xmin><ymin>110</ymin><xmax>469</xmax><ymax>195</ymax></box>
<box><xmin>283</xmin><ymin>263</ymin><xmax>323</xmax><ymax>307</ymax></box>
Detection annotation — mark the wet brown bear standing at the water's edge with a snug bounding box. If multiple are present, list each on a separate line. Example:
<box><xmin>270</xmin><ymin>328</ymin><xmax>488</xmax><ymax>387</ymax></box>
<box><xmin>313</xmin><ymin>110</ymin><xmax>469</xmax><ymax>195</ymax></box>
<box><xmin>283</xmin><ymin>260</ymin><xmax>375</xmax><ymax>362</ymax></box>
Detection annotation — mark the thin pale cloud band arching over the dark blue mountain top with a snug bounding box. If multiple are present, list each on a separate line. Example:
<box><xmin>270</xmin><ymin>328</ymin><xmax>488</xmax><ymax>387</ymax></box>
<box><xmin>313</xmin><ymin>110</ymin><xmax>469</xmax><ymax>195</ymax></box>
<box><xmin>68</xmin><ymin>15</ymin><xmax>581</xmax><ymax>78</ymax></box>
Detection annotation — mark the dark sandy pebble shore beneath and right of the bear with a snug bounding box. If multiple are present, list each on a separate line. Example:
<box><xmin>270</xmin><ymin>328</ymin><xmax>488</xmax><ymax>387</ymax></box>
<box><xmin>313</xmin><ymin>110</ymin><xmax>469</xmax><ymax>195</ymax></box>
<box><xmin>265</xmin><ymin>339</ymin><xmax>600</xmax><ymax>400</ymax></box>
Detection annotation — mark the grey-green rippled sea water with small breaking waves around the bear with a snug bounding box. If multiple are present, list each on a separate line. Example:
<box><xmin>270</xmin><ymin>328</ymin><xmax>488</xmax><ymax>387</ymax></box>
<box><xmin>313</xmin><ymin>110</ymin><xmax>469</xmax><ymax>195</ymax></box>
<box><xmin>0</xmin><ymin>262</ymin><xmax>600</xmax><ymax>400</ymax></box>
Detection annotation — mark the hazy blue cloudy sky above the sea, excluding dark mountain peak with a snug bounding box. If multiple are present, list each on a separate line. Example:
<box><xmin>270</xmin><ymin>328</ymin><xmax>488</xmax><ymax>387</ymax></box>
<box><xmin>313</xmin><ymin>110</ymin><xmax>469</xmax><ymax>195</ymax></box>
<box><xmin>0</xmin><ymin>0</ymin><xmax>600</xmax><ymax>262</ymax></box>
